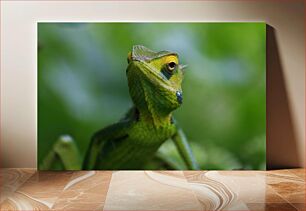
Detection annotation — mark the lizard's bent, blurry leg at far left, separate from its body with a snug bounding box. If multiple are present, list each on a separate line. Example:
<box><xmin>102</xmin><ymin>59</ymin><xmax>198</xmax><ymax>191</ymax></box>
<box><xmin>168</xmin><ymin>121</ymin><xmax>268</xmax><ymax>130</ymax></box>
<box><xmin>39</xmin><ymin>135</ymin><xmax>81</xmax><ymax>170</ymax></box>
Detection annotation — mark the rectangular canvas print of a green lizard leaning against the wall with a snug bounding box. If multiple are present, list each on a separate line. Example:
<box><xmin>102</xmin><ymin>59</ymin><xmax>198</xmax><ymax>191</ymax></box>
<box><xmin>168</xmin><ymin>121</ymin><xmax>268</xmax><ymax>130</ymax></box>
<box><xmin>37</xmin><ymin>23</ymin><xmax>266</xmax><ymax>170</ymax></box>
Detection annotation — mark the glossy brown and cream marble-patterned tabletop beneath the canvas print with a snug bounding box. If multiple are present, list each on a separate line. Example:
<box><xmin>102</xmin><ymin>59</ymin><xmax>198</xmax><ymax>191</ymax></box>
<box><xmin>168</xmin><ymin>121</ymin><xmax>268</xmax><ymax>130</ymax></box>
<box><xmin>0</xmin><ymin>169</ymin><xmax>306</xmax><ymax>211</ymax></box>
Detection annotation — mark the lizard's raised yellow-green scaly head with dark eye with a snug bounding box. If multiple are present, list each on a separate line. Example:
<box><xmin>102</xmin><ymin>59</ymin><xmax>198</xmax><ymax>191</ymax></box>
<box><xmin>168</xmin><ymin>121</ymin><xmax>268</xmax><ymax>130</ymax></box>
<box><xmin>127</xmin><ymin>45</ymin><xmax>184</xmax><ymax>117</ymax></box>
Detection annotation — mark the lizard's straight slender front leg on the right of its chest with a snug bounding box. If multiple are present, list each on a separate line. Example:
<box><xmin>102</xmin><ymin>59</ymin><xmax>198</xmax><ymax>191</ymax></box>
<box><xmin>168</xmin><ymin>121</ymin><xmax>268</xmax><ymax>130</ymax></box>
<box><xmin>172</xmin><ymin>129</ymin><xmax>199</xmax><ymax>170</ymax></box>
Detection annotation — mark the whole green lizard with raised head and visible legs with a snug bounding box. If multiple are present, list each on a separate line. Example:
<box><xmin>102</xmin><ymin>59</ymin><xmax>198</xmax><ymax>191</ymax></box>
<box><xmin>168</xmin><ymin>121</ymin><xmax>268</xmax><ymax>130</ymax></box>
<box><xmin>39</xmin><ymin>45</ymin><xmax>198</xmax><ymax>170</ymax></box>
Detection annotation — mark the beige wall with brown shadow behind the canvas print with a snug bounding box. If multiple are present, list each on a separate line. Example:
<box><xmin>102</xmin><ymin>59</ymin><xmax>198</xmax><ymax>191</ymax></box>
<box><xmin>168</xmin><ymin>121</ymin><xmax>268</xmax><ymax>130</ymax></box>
<box><xmin>1</xmin><ymin>1</ymin><xmax>305</xmax><ymax>167</ymax></box>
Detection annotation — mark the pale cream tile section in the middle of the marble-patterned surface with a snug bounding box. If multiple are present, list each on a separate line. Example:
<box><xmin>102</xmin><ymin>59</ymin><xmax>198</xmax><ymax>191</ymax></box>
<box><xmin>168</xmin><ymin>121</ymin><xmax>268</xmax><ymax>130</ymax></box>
<box><xmin>104</xmin><ymin>171</ymin><xmax>201</xmax><ymax>210</ymax></box>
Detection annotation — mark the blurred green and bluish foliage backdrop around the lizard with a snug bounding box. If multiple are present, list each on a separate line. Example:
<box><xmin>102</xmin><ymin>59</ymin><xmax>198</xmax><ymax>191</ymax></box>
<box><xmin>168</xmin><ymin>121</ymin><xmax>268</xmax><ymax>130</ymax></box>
<box><xmin>38</xmin><ymin>23</ymin><xmax>266</xmax><ymax>169</ymax></box>
